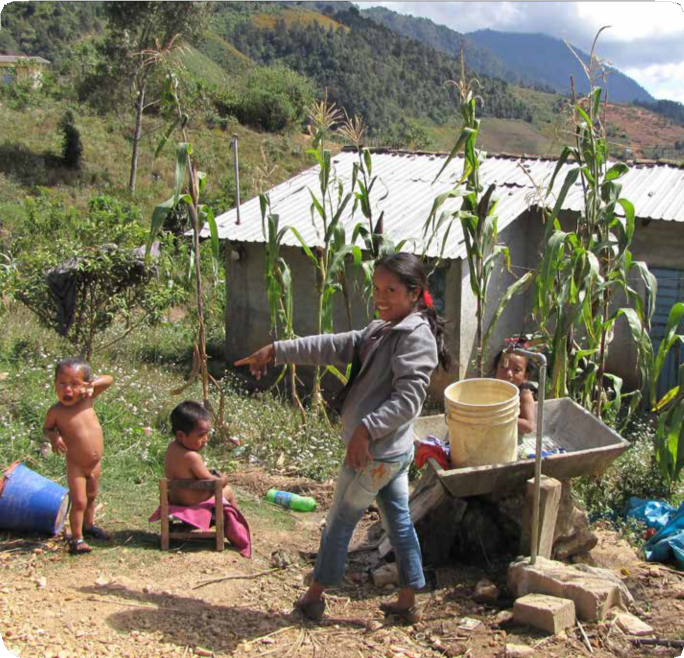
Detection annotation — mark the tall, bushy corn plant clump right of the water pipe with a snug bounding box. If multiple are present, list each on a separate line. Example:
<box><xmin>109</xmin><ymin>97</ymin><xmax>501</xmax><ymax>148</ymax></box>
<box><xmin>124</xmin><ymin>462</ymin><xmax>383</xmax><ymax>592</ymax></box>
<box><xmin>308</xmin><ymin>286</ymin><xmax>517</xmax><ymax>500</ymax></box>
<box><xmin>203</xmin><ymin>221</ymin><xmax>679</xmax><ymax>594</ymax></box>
<box><xmin>534</xmin><ymin>31</ymin><xmax>656</xmax><ymax>418</ymax></box>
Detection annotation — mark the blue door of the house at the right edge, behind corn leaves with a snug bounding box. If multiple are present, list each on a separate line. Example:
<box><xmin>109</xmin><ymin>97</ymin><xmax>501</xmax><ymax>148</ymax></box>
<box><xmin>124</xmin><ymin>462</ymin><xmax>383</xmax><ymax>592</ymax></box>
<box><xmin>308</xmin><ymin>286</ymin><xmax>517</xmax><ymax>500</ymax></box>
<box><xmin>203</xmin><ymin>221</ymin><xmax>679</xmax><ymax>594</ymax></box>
<box><xmin>651</xmin><ymin>267</ymin><xmax>684</xmax><ymax>399</ymax></box>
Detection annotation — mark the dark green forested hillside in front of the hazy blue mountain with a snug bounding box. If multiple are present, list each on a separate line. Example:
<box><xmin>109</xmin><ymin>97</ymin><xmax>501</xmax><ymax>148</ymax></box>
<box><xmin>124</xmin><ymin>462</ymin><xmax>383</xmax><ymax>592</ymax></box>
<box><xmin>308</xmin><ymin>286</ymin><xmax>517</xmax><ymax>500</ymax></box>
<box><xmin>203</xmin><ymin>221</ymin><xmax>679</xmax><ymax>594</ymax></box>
<box><xmin>216</xmin><ymin>3</ymin><xmax>531</xmax><ymax>133</ymax></box>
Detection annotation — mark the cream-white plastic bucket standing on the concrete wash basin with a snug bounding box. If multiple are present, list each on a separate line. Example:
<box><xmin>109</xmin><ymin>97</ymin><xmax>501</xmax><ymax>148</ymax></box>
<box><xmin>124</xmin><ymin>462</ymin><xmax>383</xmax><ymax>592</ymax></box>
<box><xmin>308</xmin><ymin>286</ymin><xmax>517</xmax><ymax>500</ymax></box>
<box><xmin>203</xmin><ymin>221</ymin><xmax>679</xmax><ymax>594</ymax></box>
<box><xmin>444</xmin><ymin>378</ymin><xmax>520</xmax><ymax>468</ymax></box>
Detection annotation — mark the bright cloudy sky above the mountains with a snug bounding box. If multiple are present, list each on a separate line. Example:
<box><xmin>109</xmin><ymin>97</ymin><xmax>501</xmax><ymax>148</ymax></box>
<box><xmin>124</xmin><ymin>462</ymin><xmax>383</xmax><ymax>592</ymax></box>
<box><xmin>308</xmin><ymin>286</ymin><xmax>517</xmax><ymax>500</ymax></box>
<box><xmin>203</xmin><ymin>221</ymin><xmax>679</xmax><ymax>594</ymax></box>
<box><xmin>354</xmin><ymin>0</ymin><xmax>684</xmax><ymax>103</ymax></box>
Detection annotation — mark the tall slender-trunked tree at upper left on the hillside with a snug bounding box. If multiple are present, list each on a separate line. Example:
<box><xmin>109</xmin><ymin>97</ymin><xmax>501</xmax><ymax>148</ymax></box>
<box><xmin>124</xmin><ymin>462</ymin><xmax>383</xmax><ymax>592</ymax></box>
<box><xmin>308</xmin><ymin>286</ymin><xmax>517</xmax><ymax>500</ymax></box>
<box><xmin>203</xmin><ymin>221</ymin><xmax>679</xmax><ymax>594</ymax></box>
<box><xmin>105</xmin><ymin>0</ymin><xmax>209</xmax><ymax>192</ymax></box>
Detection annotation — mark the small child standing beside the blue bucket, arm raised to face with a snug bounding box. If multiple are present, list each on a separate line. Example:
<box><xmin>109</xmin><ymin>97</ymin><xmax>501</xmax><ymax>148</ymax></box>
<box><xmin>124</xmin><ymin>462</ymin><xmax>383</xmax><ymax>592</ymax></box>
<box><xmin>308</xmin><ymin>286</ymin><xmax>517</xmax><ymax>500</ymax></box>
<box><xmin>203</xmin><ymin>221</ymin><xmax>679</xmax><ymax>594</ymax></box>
<box><xmin>43</xmin><ymin>358</ymin><xmax>114</xmax><ymax>555</ymax></box>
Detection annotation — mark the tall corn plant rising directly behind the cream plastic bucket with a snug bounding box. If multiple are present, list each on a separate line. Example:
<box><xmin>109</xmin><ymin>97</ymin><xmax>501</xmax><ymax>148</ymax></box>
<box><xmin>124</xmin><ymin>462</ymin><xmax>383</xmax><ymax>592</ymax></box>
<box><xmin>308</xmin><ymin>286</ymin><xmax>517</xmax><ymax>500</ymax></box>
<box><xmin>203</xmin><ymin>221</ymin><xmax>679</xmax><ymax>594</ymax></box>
<box><xmin>423</xmin><ymin>51</ymin><xmax>510</xmax><ymax>376</ymax></box>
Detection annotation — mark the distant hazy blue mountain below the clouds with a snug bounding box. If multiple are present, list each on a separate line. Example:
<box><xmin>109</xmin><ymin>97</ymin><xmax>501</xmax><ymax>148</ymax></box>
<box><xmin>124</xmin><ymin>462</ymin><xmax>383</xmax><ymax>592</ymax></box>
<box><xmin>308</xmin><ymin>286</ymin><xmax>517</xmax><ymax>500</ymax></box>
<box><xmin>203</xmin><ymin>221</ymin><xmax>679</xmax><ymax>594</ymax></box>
<box><xmin>466</xmin><ymin>30</ymin><xmax>655</xmax><ymax>103</ymax></box>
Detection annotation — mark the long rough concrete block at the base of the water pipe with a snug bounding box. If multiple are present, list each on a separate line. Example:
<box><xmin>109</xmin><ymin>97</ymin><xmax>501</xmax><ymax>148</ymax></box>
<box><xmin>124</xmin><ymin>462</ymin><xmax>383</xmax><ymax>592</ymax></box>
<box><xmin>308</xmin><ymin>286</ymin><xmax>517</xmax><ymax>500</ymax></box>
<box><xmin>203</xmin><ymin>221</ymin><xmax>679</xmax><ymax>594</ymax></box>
<box><xmin>508</xmin><ymin>557</ymin><xmax>621</xmax><ymax>621</ymax></box>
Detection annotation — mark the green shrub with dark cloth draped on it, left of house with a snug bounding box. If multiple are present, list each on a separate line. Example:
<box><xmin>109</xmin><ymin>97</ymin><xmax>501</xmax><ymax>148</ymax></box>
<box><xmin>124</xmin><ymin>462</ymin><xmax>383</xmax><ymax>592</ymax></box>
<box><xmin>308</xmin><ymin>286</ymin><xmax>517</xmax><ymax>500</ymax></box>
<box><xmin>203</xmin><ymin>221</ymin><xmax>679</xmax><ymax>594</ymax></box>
<box><xmin>9</xmin><ymin>196</ymin><xmax>181</xmax><ymax>357</ymax></box>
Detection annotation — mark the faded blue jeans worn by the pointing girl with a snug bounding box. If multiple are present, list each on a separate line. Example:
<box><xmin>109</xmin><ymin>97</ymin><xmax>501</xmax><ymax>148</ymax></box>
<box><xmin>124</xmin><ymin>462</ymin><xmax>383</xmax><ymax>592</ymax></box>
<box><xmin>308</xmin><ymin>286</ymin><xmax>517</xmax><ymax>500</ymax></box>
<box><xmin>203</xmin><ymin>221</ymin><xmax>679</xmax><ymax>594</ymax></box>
<box><xmin>313</xmin><ymin>449</ymin><xmax>425</xmax><ymax>589</ymax></box>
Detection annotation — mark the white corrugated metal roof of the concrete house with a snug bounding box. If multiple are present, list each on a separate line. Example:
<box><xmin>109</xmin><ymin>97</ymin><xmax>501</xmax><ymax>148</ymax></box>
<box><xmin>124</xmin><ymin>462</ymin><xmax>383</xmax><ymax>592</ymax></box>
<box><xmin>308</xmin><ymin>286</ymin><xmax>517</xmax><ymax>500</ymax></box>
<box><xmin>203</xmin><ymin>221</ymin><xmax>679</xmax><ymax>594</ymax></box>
<box><xmin>208</xmin><ymin>151</ymin><xmax>684</xmax><ymax>259</ymax></box>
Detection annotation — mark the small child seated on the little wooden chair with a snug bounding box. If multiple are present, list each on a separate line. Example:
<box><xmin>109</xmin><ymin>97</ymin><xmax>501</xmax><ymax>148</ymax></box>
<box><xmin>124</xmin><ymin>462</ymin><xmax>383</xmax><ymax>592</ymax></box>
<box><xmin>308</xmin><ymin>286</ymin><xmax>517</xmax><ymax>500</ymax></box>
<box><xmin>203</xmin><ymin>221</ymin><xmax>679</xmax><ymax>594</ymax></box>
<box><xmin>164</xmin><ymin>400</ymin><xmax>237</xmax><ymax>509</ymax></box>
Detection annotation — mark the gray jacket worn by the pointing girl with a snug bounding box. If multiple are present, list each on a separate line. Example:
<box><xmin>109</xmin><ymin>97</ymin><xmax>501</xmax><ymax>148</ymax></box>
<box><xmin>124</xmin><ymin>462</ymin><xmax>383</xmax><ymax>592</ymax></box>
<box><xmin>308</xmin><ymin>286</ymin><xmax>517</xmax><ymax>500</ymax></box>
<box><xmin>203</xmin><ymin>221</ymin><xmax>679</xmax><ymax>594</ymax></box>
<box><xmin>275</xmin><ymin>313</ymin><xmax>437</xmax><ymax>460</ymax></box>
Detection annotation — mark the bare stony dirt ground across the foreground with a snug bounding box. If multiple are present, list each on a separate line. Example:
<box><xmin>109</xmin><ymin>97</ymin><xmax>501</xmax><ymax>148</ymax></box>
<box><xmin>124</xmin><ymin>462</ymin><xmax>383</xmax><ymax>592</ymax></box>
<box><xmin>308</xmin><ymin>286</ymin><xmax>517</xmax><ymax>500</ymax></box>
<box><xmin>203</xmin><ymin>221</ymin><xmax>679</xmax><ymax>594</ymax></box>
<box><xmin>0</xmin><ymin>468</ymin><xmax>684</xmax><ymax>658</ymax></box>
